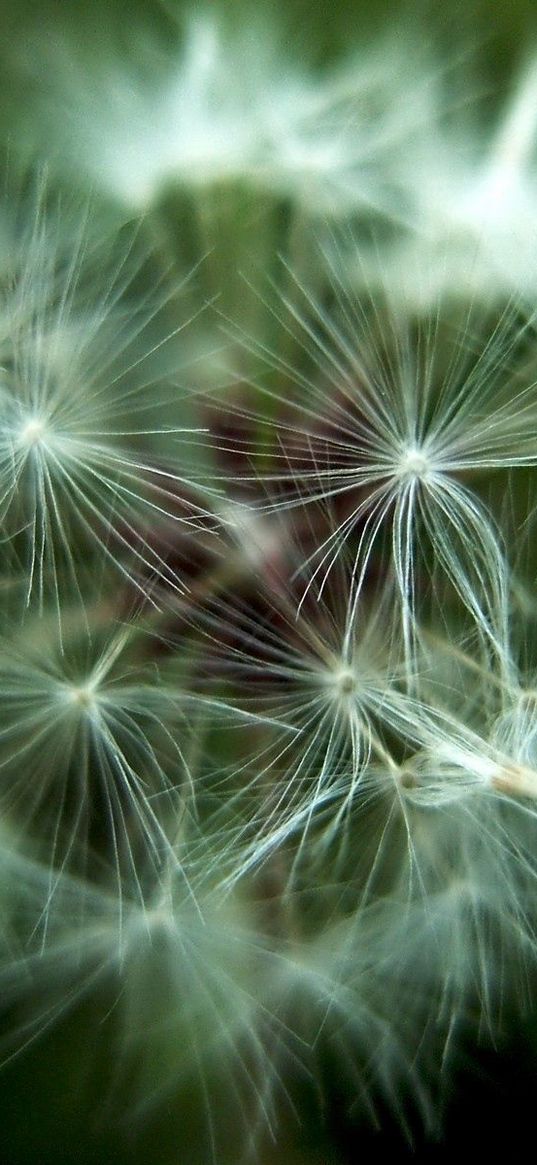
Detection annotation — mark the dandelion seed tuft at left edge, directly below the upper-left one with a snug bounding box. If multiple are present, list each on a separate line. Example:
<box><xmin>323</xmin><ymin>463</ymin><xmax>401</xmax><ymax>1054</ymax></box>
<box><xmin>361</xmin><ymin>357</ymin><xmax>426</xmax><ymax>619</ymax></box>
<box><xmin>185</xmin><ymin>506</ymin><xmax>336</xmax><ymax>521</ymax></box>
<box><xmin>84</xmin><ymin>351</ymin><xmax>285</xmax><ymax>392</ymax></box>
<box><xmin>0</xmin><ymin>620</ymin><xmax>190</xmax><ymax>882</ymax></box>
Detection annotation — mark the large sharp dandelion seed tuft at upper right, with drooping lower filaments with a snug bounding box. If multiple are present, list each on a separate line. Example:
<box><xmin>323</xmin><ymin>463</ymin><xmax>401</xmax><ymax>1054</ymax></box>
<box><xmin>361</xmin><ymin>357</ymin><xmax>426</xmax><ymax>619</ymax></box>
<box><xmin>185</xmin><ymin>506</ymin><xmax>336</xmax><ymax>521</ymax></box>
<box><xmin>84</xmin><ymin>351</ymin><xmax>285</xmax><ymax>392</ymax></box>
<box><xmin>229</xmin><ymin>258</ymin><xmax>537</xmax><ymax>670</ymax></box>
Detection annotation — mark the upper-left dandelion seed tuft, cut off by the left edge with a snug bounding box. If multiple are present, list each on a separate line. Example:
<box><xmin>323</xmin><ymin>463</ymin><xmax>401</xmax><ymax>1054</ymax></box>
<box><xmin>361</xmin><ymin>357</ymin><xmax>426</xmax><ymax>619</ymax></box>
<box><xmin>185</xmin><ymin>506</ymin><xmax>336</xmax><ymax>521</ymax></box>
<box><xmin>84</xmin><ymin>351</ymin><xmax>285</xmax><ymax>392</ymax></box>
<box><xmin>0</xmin><ymin>185</ymin><xmax>217</xmax><ymax>602</ymax></box>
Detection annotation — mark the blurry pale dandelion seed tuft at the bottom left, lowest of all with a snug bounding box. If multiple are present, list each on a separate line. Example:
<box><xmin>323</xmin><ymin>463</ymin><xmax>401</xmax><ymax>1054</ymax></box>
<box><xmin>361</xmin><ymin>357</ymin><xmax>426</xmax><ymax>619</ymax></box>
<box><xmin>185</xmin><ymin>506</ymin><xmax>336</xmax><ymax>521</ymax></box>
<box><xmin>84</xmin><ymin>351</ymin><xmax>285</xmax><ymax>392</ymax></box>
<box><xmin>0</xmin><ymin>836</ymin><xmax>299</xmax><ymax>1163</ymax></box>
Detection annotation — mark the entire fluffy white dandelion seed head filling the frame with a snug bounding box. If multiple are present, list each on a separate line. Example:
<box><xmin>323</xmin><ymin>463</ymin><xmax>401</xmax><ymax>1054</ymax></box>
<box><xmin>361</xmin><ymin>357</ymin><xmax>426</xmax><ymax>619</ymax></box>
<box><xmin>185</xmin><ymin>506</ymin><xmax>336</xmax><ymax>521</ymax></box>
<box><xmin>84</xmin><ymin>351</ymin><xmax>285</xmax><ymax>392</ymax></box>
<box><xmin>0</xmin><ymin>25</ymin><xmax>537</xmax><ymax>1146</ymax></box>
